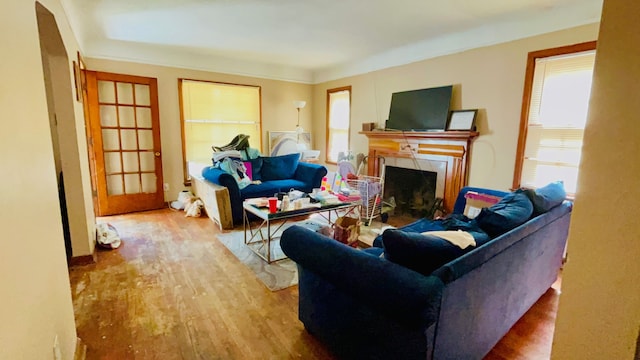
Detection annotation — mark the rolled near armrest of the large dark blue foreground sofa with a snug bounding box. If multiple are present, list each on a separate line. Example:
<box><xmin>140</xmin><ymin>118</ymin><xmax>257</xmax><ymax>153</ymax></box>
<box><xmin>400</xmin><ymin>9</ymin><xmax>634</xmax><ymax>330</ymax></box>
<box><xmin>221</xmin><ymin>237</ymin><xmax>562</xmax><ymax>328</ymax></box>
<box><xmin>280</xmin><ymin>225</ymin><xmax>444</xmax><ymax>326</ymax></box>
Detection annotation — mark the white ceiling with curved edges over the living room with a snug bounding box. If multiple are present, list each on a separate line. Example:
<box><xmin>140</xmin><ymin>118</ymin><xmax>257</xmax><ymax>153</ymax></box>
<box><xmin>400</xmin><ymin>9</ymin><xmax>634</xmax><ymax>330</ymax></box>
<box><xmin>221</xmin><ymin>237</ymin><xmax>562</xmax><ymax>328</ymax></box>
<box><xmin>62</xmin><ymin>0</ymin><xmax>602</xmax><ymax>83</ymax></box>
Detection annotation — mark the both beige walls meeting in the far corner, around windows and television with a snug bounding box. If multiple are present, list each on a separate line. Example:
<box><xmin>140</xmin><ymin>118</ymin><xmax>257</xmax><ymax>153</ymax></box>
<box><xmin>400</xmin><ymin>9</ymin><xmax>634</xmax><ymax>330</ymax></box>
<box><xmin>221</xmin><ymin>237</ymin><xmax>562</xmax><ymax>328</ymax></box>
<box><xmin>87</xmin><ymin>24</ymin><xmax>598</xmax><ymax>200</ymax></box>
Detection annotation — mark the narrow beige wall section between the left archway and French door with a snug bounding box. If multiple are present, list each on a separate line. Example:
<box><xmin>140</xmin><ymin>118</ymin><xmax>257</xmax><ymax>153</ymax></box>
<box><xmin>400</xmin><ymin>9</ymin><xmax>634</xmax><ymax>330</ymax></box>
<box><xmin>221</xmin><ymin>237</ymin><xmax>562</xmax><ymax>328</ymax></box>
<box><xmin>37</xmin><ymin>0</ymin><xmax>95</xmax><ymax>257</ymax></box>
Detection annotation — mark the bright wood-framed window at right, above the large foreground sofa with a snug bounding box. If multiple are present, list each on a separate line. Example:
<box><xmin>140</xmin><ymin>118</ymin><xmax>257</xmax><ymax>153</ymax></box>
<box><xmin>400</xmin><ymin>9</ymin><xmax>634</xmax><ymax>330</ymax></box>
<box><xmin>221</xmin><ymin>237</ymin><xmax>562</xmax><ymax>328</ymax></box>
<box><xmin>513</xmin><ymin>42</ymin><xmax>596</xmax><ymax>194</ymax></box>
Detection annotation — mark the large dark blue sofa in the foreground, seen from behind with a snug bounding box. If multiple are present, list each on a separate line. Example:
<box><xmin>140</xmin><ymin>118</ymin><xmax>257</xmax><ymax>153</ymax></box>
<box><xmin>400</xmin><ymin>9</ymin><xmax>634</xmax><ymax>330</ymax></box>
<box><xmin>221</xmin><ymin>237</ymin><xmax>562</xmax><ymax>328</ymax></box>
<box><xmin>281</xmin><ymin>187</ymin><xmax>572</xmax><ymax>359</ymax></box>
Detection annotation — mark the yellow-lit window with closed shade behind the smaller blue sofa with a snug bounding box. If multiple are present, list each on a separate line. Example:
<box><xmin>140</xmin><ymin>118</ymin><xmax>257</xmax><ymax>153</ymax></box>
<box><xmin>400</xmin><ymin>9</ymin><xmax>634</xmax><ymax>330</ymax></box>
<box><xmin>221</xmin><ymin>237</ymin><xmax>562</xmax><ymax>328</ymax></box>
<box><xmin>178</xmin><ymin>79</ymin><xmax>262</xmax><ymax>182</ymax></box>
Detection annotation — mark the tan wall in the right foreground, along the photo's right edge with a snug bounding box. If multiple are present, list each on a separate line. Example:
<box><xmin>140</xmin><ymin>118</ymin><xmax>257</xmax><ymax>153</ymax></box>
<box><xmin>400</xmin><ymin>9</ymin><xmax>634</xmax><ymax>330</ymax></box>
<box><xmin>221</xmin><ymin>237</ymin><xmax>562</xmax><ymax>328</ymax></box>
<box><xmin>552</xmin><ymin>0</ymin><xmax>640</xmax><ymax>360</ymax></box>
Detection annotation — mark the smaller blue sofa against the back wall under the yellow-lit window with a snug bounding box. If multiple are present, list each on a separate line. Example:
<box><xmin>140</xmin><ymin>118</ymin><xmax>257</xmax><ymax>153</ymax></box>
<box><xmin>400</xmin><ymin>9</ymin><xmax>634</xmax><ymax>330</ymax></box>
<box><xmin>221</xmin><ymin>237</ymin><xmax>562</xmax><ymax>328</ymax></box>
<box><xmin>202</xmin><ymin>154</ymin><xmax>327</xmax><ymax>224</ymax></box>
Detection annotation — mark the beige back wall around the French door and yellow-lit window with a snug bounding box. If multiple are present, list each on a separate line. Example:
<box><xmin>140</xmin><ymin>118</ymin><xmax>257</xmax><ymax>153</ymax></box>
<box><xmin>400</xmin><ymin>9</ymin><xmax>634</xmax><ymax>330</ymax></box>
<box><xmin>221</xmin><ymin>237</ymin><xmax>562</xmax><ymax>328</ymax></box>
<box><xmin>86</xmin><ymin>59</ymin><xmax>311</xmax><ymax>201</ymax></box>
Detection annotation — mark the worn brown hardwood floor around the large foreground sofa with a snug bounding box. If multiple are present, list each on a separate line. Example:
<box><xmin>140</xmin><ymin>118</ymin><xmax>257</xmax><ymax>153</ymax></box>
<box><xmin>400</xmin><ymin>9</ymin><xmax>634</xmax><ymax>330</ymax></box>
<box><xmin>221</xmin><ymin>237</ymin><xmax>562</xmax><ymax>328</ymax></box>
<box><xmin>69</xmin><ymin>209</ymin><xmax>559</xmax><ymax>360</ymax></box>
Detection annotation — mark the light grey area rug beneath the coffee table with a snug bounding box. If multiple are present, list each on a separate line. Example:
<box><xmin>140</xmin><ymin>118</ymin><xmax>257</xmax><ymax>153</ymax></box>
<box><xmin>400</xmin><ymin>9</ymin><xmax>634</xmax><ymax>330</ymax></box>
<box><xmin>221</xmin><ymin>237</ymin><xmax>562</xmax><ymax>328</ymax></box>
<box><xmin>218</xmin><ymin>220</ymin><xmax>324</xmax><ymax>291</ymax></box>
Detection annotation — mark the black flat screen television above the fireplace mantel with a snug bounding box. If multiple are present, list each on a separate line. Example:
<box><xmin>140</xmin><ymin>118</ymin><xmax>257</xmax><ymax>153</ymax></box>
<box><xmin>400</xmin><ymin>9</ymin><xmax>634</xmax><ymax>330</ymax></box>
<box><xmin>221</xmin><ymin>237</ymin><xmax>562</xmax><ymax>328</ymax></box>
<box><xmin>385</xmin><ymin>85</ymin><xmax>453</xmax><ymax>131</ymax></box>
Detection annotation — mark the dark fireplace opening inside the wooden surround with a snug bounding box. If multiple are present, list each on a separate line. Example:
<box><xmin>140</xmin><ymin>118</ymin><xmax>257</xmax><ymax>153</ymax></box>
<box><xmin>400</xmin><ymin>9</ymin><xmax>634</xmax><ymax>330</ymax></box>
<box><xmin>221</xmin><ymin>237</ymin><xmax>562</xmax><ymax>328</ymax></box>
<box><xmin>383</xmin><ymin>165</ymin><xmax>442</xmax><ymax>218</ymax></box>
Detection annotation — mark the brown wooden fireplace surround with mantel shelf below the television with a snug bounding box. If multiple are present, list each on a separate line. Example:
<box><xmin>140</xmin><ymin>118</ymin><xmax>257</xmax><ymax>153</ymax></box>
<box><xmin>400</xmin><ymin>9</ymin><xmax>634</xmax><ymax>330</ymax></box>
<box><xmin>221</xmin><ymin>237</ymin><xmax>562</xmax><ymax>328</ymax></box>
<box><xmin>360</xmin><ymin>130</ymin><xmax>479</xmax><ymax>212</ymax></box>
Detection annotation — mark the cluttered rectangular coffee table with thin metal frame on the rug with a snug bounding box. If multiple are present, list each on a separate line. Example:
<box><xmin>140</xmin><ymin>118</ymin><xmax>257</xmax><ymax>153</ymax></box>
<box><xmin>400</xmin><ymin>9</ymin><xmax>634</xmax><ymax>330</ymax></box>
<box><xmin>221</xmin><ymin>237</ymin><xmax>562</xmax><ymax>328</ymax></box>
<box><xmin>242</xmin><ymin>201</ymin><xmax>361</xmax><ymax>264</ymax></box>
